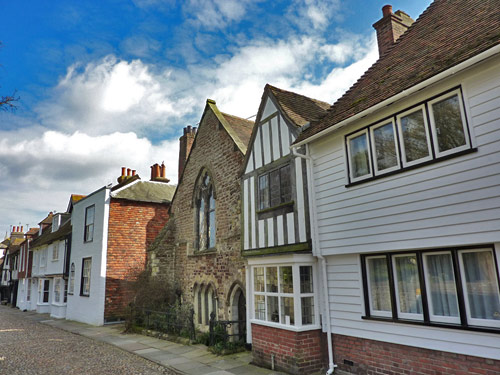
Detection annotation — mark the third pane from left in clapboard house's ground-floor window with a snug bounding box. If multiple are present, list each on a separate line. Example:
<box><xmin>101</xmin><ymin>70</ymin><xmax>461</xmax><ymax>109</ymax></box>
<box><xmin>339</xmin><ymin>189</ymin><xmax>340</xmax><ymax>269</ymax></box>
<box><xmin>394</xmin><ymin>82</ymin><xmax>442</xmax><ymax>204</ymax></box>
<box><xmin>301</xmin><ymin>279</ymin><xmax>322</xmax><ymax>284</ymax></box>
<box><xmin>425</xmin><ymin>253</ymin><xmax>458</xmax><ymax>317</ymax></box>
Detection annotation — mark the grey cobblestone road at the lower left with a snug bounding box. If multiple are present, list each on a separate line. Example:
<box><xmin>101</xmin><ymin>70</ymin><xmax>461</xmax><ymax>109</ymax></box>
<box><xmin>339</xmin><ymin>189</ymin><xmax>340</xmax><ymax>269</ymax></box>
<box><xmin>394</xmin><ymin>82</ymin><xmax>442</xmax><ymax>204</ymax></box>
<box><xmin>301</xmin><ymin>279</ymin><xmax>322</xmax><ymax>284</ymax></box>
<box><xmin>0</xmin><ymin>306</ymin><xmax>174</xmax><ymax>375</ymax></box>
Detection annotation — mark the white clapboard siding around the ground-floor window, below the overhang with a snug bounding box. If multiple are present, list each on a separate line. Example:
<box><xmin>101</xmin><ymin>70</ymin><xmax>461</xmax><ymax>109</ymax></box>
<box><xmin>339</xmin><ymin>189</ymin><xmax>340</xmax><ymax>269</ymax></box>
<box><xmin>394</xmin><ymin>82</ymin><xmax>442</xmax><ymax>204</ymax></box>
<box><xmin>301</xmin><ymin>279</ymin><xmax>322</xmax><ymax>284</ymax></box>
<box><xmin>327</xmin><ymin>249</ymin><xmax>500</xmax><ymax>359</ymax></box>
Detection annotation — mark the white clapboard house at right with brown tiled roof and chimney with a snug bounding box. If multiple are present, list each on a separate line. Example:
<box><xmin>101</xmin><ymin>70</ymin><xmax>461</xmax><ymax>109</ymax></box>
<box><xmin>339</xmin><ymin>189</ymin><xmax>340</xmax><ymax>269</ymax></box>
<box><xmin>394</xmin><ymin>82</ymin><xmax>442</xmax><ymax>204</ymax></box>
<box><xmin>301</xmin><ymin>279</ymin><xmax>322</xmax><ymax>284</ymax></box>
<box><xmin>292</xmin><ymin>0</ymin><xmax>500</xmax><ymax>374</ymax></box>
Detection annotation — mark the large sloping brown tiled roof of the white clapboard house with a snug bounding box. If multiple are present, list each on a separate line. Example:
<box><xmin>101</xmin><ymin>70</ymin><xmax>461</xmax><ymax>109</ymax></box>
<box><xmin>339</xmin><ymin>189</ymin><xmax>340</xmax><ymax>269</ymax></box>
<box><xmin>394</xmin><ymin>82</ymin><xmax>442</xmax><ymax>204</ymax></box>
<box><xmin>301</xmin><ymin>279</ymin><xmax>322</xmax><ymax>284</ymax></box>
<box><xmin>296</xmin><ymin>0</ymin><xmax>500</xmax><ymax>142</ymax></box>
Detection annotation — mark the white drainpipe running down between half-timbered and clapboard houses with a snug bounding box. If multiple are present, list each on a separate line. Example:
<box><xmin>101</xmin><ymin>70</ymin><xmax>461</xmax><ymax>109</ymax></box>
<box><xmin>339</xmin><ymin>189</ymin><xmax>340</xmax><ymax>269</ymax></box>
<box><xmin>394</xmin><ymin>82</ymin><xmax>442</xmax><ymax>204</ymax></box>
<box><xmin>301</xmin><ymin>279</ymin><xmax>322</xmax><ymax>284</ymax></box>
<box><xmin>291</xmin><ymin>144</ymin><xmax>337</xmax><ymax>375</ymax></box>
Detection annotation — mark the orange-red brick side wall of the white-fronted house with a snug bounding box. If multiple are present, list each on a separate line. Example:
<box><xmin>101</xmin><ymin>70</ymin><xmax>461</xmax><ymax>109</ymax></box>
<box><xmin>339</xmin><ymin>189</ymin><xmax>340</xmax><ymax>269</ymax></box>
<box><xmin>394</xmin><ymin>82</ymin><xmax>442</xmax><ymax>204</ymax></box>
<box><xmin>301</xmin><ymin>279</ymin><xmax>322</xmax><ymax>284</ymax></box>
<box><xmin>104</xmin><ymin>199</ymin><xmax>169</xmax><ymax>321</ymax></box>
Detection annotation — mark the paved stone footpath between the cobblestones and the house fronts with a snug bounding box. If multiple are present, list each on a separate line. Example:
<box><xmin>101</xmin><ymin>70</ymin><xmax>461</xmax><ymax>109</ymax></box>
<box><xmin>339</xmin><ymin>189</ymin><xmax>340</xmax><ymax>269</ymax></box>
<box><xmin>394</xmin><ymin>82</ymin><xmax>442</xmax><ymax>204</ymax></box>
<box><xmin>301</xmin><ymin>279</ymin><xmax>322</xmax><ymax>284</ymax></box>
<box><xmin>19</xmin><ymin>311</ymin><xmax>285</xmax><ymax>375</ymax></box>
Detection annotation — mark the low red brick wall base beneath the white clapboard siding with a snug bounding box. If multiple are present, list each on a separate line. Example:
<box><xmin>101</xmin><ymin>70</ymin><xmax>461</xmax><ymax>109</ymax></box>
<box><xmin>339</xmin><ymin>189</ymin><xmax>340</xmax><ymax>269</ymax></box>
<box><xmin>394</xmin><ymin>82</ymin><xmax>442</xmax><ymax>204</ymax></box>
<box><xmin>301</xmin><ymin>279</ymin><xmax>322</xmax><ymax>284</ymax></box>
<box><xmin>333</xmin><ymin>335</ymin><xmax>500</xmax><ymax>375</ymax></box>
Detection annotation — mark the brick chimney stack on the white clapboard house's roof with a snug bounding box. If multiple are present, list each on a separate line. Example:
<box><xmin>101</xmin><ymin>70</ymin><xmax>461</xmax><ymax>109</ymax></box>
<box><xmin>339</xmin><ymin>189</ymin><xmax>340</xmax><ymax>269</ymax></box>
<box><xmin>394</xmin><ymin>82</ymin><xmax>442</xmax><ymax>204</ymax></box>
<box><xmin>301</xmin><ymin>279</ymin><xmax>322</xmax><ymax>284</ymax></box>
<box><xmin>373</xmin><ymin>5</ymin><xmax>415</xmax><ymax>56</ymax></box>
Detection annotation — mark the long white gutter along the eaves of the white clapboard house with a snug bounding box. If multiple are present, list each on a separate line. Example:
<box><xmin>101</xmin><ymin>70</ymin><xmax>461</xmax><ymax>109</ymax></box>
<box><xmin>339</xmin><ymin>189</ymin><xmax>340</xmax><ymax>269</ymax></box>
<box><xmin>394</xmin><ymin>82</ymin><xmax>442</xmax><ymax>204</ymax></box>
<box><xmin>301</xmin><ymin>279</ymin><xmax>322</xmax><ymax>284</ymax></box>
<box><xmin>292</xmin><ymin>44</ymin><xmax>500</xmax><ymax>149</ymax></box>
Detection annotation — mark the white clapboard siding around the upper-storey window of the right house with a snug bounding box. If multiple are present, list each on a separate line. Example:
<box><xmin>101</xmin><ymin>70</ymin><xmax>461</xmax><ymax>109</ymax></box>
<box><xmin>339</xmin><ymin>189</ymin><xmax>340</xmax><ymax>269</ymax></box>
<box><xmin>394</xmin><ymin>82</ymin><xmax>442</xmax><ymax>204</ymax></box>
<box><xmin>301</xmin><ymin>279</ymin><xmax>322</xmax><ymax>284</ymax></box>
<box><xmin>310</xmin><ymin>60</ymin><xmax>500</xmax><ymax>255</ymax></box>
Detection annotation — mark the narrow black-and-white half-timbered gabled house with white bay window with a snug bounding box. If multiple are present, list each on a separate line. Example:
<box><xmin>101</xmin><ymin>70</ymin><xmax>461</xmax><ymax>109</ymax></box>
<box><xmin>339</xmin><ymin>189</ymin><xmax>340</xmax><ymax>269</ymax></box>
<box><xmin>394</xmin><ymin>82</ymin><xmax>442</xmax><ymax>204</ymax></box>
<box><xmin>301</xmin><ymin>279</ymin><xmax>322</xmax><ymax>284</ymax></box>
<box><xmin>242</xmin><ymin>85</ymin><xmax>329</xmax><ymax>373</ymax></box>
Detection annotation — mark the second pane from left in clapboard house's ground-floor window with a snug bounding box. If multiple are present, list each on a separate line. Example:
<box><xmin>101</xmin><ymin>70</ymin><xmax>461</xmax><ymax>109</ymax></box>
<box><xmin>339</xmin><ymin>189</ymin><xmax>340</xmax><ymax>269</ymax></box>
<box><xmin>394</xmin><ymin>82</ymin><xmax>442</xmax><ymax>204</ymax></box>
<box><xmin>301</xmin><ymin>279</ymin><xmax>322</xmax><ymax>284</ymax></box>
<box><xmin>395</xmin><ymin>255</ymin><xmax>422</xmax><ymax>314</ymax></box>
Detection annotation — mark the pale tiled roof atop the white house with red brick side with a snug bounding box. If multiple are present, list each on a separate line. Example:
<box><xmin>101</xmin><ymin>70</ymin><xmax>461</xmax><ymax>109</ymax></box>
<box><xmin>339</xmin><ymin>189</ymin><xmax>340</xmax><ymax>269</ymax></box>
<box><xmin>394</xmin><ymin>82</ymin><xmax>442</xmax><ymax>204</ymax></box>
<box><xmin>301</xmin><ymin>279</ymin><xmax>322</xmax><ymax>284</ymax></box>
<box><xmin>111</xmin><ymin>181</ymin><xmax>176</xmax><ymax>203</ymax></box>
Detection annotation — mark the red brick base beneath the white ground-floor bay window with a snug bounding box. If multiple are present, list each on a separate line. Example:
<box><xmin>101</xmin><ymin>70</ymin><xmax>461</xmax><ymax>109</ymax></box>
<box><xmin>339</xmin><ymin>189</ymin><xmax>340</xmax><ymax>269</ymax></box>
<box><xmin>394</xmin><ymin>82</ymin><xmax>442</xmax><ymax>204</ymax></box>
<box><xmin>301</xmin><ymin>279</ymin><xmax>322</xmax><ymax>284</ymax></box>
<box><xmin>252</xmin><ymin>324</ymin><xmax>327</xmax><ymax>374</ymax></box>
